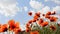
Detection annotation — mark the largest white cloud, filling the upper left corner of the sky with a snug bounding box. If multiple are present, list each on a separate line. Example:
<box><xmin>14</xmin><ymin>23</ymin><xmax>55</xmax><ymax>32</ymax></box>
<box><xmin>0</xmin><ymin>0</ymin><xmax>19</xmax><ymax>16</ymax></box>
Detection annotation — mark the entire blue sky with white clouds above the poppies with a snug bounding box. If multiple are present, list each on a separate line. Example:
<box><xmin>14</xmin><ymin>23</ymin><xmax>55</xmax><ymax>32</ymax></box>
<box><xmin>0</xmin><ymin>0</ymin><xmax>60</xmax><ymax>29</ymax></box>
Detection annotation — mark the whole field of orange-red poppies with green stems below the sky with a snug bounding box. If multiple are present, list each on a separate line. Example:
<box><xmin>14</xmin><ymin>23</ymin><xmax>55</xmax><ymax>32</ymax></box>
<box><xmin>0</xmin><ymin>11</ymin><xmax>60</xmax><ymax>34</ymax></box>
